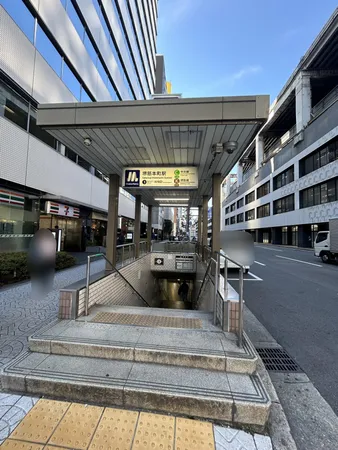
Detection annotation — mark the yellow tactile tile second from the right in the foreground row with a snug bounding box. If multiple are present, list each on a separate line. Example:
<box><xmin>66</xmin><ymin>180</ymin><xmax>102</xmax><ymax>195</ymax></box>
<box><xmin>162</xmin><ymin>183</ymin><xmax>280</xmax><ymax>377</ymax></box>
<box><xmin>132</xmin><ymin>412</ymin><xmax>174</xmax><ymax>450</ymax></box>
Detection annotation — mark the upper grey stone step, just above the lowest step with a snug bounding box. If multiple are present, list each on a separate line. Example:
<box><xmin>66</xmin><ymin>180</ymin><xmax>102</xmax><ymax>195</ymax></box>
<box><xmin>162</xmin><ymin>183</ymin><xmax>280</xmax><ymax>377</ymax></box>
<box><xmin>29</xmin><ymin>321</ymin><xmax>257</xmax><ymax>374</ymax></box>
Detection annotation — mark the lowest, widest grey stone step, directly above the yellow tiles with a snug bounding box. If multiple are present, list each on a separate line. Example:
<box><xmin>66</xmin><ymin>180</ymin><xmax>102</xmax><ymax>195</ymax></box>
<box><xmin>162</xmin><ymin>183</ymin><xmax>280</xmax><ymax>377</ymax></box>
<box><xmin>1</xmin><ymin>352</ymin><xmax>271</xmax><ymax>431</ymax></box>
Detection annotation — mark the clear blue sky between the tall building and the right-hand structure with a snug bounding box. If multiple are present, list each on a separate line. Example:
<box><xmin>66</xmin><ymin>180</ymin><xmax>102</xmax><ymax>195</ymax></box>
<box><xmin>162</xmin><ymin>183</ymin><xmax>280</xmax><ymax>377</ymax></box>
<box><xmin>157</xmin><ymin>0</ymin><xmax>337</xmax><ymax>101</ymax></box>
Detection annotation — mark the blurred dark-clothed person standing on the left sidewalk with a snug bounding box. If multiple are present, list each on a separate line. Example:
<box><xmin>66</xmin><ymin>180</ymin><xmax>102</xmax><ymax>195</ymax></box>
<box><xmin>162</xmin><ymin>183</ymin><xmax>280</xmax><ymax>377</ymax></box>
<box><xmin>28</xmin><ymin>229</ymin><xmax>56</xmax><ymax>299</ymax></box>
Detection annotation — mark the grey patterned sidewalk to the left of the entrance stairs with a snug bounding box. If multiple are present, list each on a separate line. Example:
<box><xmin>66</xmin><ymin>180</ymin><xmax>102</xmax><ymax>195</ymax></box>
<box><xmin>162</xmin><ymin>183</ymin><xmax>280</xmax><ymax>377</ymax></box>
<box><xmin>0</xmin><ymin>260</ymin><xmax>105</xmax><ymax>371</ymax></box>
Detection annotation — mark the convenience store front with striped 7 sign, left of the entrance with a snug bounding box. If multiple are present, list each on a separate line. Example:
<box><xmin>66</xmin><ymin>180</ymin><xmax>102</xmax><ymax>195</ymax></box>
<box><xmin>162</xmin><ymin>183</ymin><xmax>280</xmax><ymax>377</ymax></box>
<box><xmin>39</xmin><ymin>201</ymin><xmax>85</xmax><ymax>252</ymax></box>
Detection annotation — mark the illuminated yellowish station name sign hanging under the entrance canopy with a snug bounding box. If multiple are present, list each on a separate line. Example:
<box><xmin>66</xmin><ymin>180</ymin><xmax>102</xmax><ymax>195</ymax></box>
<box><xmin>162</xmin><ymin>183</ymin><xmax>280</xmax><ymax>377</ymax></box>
<box><xmin>123</xmin><ymin>167</ymin><xmax>198</xmax><ymax>189</ymax></box>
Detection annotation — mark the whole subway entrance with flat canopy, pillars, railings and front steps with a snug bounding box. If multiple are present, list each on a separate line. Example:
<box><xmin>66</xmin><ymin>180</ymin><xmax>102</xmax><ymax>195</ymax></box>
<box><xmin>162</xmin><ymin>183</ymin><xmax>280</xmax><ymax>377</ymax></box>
<box><xmin>2</xmin><ymin>96</ymin><xmax>271</xmax><ymax>431</ymax></box>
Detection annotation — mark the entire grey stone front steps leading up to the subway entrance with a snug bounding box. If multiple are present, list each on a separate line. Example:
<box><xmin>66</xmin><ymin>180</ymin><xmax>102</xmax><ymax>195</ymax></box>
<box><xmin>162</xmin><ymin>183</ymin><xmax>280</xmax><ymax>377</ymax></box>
<box><xmin>2</xmin><ymin>307</ymin><xmax>270</xmax><ymax>431</ymax></box>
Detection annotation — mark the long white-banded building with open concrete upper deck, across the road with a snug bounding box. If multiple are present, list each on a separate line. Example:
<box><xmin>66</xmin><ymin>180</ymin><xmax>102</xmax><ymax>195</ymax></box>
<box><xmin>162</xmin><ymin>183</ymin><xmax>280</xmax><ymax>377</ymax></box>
<box><xmin>222</xmin><ymin>9</ymin><xmax>338</xmax><ymax>247</ymax></box>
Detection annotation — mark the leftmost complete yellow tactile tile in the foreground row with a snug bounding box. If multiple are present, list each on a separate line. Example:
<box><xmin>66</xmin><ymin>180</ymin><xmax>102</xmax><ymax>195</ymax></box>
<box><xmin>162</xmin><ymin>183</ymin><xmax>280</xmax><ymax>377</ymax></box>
<box><xmin>11</xmin><ymin>400</ymin><xmax>70</xmax><ymax>444</ymax></box>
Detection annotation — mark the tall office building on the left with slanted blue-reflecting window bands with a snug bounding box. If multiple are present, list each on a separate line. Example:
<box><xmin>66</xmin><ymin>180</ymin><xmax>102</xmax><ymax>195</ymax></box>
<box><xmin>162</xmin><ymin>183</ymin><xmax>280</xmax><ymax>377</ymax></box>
<box><xmin>0</xmin><ymin>0</ymin><xmax>157</xmax><ymax>251</ymax></box>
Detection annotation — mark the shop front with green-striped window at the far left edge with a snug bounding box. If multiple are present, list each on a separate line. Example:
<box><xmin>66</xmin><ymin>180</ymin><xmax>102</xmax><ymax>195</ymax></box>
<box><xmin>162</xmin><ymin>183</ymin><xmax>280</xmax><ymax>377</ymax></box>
<box><xmin>0</xmin><ymin>187</ymin><xmax>39</xmax><ymax>252</ymax></box>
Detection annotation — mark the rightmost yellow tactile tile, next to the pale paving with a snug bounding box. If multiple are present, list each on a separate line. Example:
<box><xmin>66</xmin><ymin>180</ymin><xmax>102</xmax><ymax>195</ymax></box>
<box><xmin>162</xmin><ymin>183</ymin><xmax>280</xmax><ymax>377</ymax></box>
<box><xmin>175</xmin><ymin>417</ymin><xmax>215</xmax><ymax>450</ymax></box>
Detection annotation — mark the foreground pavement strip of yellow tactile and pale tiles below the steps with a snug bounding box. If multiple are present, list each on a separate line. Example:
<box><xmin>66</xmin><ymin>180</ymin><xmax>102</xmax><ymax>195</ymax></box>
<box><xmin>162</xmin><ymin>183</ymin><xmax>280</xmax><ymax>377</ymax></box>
<box><xmin>0</xmin><ymin>394</ymin><xmax>272</xmax><ymax>450</ymax></box>
